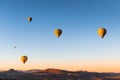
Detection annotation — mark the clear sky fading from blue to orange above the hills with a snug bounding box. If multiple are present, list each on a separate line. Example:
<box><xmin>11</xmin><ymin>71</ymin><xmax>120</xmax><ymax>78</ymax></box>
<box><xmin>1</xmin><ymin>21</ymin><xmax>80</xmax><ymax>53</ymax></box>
<box><xmin>0</xmin><ymin>0</ymin><xmax>120</xmax><ymax>72</ymax></box>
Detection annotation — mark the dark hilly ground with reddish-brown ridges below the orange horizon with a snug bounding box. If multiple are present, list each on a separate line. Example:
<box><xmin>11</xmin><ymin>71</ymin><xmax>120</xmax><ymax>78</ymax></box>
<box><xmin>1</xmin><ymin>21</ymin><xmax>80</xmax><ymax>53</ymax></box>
<box><xmin>0</xmin><ymin>69</ymin><xmax>120</xmax><ymax>80</ymax></box>
